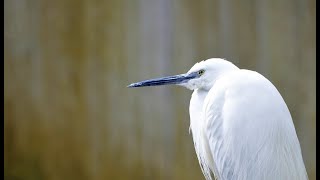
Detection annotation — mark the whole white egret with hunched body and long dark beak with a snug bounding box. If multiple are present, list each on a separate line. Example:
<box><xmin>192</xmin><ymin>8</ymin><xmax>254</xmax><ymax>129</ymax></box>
<box><xmin>128</xmin><ymin>58</ymin><xmax>308</xmax><ymax>180</ymax></box>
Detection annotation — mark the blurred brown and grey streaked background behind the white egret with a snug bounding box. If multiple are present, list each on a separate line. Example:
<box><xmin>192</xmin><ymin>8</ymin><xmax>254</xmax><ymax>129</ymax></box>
<box><xmin>4</xmin><ymin>0</ymin><xmax>316</xmax><ymax>180</ymax></box>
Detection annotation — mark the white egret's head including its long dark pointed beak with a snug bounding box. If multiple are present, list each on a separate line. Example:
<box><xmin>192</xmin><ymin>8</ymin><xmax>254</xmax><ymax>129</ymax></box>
<box><xmin>128</xmin><ymin>58</ymin><xmax>238</xmax><ymax>90</ymax></box>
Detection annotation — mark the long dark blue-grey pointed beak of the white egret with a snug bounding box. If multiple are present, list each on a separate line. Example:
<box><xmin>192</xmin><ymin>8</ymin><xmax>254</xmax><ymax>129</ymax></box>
<box><xmin>127</xmin><ymin>73</ymin><xmax>197</xmax><ymax>88</ymax></box>
